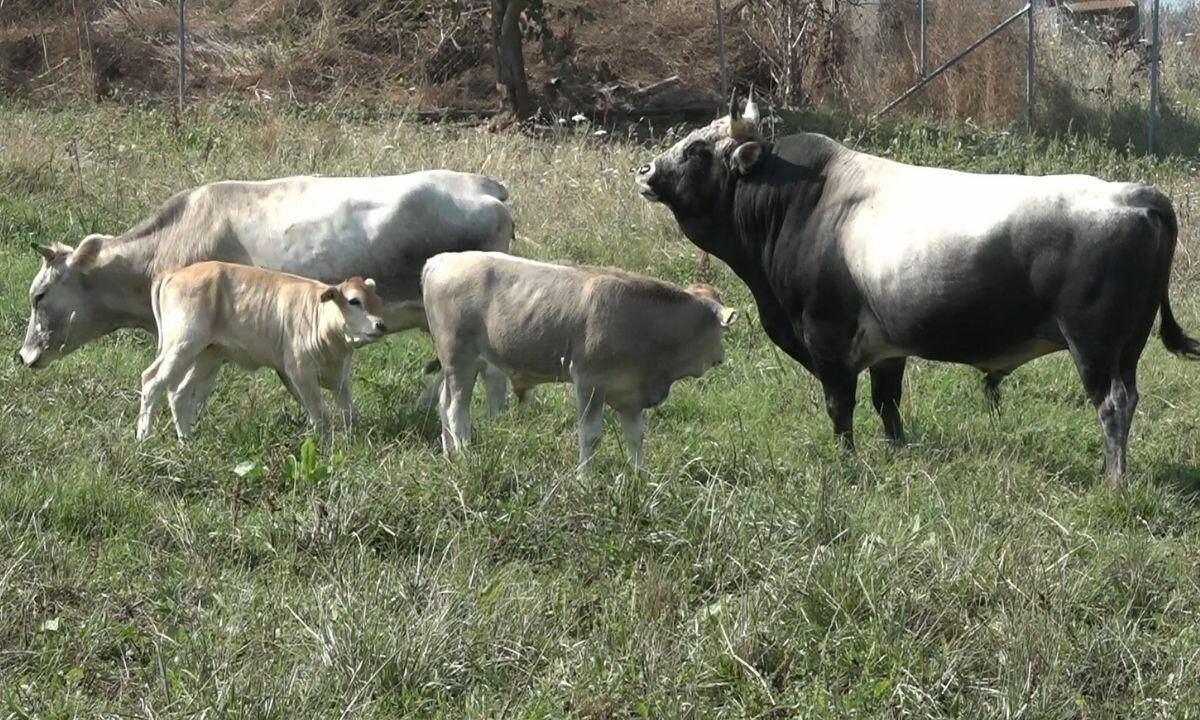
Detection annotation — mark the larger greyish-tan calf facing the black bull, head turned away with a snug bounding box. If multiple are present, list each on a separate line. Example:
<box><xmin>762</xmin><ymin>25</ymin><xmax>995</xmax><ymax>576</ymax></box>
<box><xmin>421</xmin><ymin>252</ymin><xmax>738</xmax><ymax>472</ymax></box>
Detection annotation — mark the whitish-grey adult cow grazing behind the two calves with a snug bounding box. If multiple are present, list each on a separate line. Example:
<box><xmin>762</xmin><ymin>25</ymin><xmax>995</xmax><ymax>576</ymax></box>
<box><xmin>17</xmin><ymin>170</ymin><xmax>512</xmax><ymax>391</ymax></box>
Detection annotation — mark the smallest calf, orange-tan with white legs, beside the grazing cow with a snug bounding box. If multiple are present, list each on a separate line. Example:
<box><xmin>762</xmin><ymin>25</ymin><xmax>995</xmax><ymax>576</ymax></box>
<box><xmin>137</xmin><ymin>262</ymin><xmax>388</xmax><ymax>440</ymax></box>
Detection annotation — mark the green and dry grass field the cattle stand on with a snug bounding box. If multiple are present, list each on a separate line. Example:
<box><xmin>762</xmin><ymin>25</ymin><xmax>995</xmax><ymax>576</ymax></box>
<box><xmin>0</xmin><ymin>106</ymin><xmax>1200</xmax><ymax>720</ymax></box>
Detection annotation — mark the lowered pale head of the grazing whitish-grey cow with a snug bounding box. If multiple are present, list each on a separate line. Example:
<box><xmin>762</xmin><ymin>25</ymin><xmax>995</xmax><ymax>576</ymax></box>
<box><xmin>17</xmin><ymin>235</ymin><xmax>110</xmax><ymax>367</ymax></box>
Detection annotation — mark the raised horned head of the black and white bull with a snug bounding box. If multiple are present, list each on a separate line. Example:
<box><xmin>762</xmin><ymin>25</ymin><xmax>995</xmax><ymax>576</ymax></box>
<box><xmin>635</xmin><ymin>91</ymin><xmax>769</xmax><ymax>215</ymax></box>
